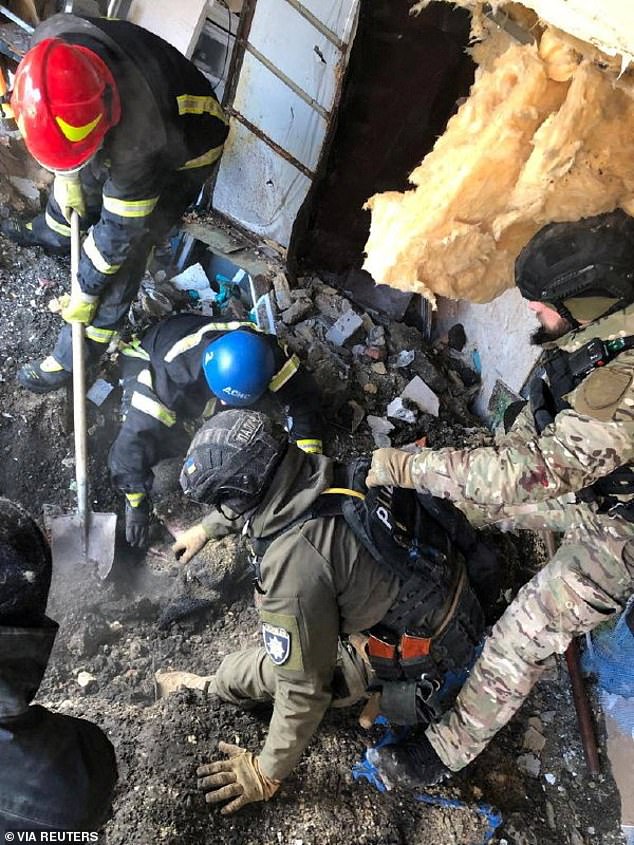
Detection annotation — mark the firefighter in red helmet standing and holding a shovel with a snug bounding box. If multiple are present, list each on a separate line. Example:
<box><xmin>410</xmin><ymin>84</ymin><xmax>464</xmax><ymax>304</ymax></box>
<box><xmin>1</xmin><ymin>14</ymin><xmax>228</xmax><ymax>393</ymax></box>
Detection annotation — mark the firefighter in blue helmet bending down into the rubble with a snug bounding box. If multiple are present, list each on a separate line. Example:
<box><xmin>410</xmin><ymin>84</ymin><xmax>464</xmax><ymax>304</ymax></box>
<box><xmin>108</xmin><ymin>313</ymin><xmax>322</xmax><ymax>548</ymax></box>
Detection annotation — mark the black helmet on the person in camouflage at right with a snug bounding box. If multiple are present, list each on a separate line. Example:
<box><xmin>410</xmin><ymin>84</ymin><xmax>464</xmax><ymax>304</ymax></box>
<box><xmin>515</xmin><ymin>209</ymin><xmax>634</xmax><ymax>327</ymax></box>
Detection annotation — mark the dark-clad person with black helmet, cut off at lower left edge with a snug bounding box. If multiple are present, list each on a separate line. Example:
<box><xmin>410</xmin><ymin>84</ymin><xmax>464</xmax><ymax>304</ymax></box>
<box><xmin>0</xmin><ymin>499</ymin><xmax>117</xmax><ymax>842</ymax></box>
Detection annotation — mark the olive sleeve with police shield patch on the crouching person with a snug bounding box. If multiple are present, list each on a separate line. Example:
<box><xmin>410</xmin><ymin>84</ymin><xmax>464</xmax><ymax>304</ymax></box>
<box><xmin>260</xmin><ymin>531</ymin><xmax>339</xmax><ymax>780</ymax></box>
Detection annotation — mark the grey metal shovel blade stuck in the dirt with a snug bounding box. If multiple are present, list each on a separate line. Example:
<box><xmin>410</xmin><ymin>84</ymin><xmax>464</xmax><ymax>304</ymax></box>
<box><xmin>50</xmin><ymin>512</ymin><xmax>117</xmax><ymax>579</ymax></box>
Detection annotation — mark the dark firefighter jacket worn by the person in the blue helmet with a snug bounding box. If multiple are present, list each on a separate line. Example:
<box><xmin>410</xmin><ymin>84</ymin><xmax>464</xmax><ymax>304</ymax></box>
<box><xmin>109</xmin><ymin>314</ymin><xmax>322</xmax><ymax>493</ymax></box>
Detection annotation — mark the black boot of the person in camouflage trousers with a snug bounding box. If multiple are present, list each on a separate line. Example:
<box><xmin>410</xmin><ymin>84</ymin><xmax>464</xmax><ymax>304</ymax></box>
<box><xmin>367</xmin><ymin>734</ymin><xmax>451</xmax><ymax>789</ymax></box>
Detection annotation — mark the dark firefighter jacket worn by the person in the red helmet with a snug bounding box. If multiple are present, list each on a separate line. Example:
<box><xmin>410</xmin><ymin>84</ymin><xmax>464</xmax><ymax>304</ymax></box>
<box><xmin>31</xmin><ymin>14</ymin><xmax>228</xmax><ymax>295</ymax></box>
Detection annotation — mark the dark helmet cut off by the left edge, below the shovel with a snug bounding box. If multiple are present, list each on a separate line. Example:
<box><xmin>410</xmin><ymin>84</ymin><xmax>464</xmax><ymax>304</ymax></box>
<box><xmin>0</xmin><ymin>499</ymin><xmax>51</xmax><ymax>627</ymax></box>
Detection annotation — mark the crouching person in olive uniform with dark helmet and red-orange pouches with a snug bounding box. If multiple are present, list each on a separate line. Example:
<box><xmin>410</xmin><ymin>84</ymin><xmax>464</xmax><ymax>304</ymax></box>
<box><xmin>173</xmin><ymin>410</ymin><xmax>495</xmax><ymax>814</ymax></box>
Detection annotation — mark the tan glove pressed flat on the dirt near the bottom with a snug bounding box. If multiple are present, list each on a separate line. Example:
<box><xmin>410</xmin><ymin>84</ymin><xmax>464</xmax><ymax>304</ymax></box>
<box><xmin>196</xmin><ymin>742</ymin><xmax>281</xmax><ymax>816</ymax></box>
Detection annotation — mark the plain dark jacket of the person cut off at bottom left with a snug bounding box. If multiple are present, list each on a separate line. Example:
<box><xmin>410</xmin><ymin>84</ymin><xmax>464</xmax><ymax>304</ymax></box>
<box><xmin>0</xmin><ymin>620</ymin><xmax>117</xmax><ymax>842</ymax></box>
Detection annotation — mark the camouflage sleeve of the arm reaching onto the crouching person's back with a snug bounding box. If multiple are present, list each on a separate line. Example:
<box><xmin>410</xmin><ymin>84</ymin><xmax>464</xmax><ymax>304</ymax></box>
<box><xmin>411</xmin><ymin>411</ymin><xmax>634</xmax><ymax>505</ymax></box>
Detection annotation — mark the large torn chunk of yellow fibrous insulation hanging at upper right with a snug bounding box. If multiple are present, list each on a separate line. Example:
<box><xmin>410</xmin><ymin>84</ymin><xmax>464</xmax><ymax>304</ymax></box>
<box><xmin>364</xmin><ymin>29</ymin><xmax>634</xmax><ymax>302</ymax></box>
